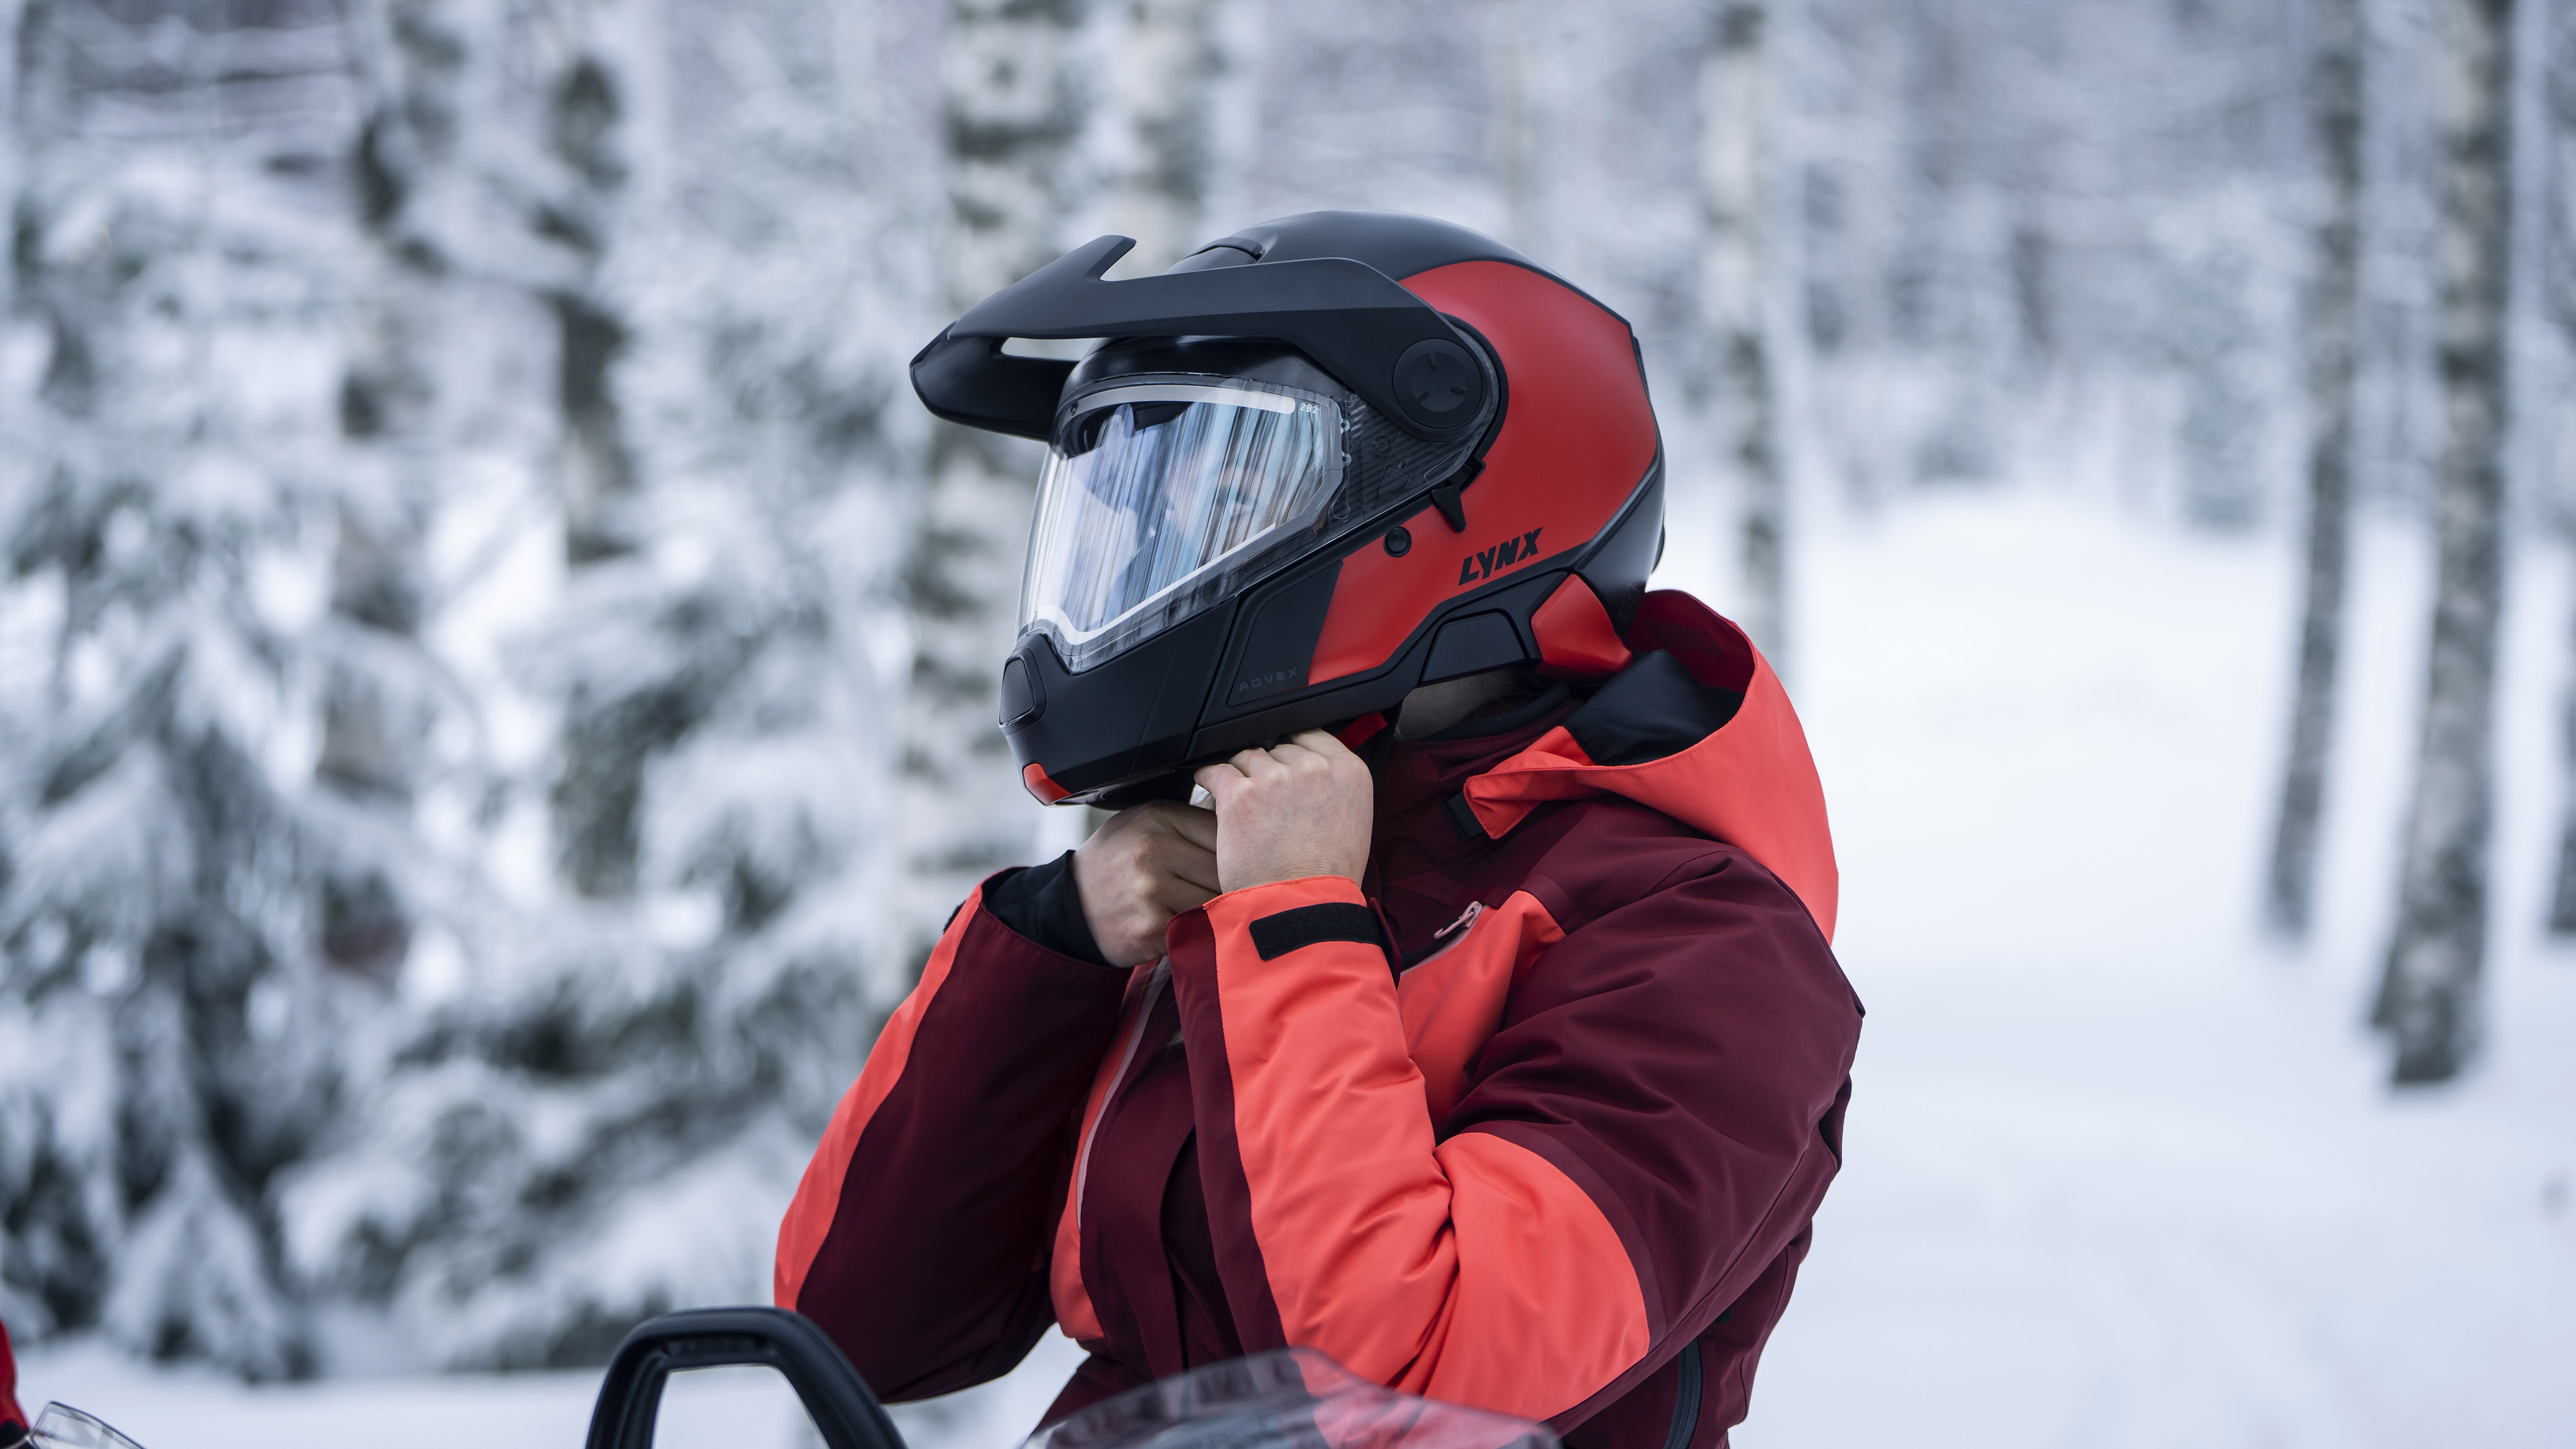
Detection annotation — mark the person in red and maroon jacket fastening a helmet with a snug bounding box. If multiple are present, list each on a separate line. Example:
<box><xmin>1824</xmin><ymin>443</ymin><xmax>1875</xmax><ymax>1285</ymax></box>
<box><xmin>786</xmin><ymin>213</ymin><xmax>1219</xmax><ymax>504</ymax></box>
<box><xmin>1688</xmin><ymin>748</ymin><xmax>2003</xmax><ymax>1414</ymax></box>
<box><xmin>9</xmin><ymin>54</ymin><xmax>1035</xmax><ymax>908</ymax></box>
<box><xmin>775</xmin><ymin>211</ymin><xmax>1860</xmax><ymax>1449</ymax></box>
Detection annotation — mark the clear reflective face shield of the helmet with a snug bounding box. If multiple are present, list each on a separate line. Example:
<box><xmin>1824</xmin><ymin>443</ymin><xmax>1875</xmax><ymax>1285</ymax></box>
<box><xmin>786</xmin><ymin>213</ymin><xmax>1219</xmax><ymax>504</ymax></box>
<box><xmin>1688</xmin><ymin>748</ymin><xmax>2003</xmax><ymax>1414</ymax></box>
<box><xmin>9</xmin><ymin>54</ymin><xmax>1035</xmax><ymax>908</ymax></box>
<box><xmin>1020</xmin><ymin>379</ymin><xmax>1342</xmax><ymax>673</ymax></box>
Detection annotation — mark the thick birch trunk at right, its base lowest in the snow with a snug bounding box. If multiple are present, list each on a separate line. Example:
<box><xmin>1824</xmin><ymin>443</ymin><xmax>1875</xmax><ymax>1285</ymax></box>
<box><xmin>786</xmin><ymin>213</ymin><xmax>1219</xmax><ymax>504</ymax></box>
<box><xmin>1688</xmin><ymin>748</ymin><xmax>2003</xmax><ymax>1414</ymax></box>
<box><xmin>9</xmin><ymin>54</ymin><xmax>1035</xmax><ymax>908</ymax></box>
<box><xmin>2370</xmin><ymin>0</ymin><xmax>2512</xmax><ymax>1085</ymax></box>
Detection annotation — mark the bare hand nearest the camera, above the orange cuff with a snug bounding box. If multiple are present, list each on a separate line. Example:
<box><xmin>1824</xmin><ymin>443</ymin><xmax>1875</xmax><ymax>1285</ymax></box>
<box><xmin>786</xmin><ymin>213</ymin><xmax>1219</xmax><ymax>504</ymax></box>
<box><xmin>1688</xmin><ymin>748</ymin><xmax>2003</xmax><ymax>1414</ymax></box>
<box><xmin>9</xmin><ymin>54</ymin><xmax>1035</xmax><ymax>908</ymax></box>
<box><xmin>1198</xmin><ymin>730</ymin><xmax>1375</xmax><ymax>889</ymax></box>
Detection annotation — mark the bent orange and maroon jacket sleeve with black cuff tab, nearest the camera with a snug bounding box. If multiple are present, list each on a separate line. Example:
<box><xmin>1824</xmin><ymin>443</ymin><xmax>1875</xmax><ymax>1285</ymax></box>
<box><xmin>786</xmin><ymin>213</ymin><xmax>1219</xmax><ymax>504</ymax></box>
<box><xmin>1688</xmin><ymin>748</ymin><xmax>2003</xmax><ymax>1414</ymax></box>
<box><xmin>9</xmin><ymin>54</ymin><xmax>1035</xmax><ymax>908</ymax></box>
<box><xmin>1172</xmin><ymin>853</ymin><xmax>1857</xmax><ymax>1418</ymax></box>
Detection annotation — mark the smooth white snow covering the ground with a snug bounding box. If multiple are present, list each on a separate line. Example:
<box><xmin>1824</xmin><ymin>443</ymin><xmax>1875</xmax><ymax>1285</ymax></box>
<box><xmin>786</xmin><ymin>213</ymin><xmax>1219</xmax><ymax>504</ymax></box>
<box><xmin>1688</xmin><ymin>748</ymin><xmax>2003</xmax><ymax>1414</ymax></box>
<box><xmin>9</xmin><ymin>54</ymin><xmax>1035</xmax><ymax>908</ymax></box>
<box><xmin>23</xmin><ymin>495</ymin><xmax>2576</xmax><ymax>1449</ymax></box>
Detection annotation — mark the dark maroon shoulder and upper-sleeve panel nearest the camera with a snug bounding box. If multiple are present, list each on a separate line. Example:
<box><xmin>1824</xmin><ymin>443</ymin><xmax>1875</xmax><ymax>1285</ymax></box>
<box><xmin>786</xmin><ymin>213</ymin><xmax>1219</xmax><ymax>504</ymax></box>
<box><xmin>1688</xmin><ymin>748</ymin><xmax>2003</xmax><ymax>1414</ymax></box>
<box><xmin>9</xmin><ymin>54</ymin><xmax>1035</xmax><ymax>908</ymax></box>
<box><xmin>1440</xmin><ymin>802</ymin><xmax>1860</xmax><ymax>1444</ymax></box>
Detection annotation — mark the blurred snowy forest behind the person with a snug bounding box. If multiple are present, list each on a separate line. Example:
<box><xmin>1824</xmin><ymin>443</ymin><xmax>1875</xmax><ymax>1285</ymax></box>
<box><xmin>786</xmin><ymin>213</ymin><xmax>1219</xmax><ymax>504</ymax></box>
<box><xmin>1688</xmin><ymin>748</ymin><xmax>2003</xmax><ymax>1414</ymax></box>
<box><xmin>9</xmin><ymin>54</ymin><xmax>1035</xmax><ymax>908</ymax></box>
<box><xmin>0</xmin><ymin>0</ymin><xmax>2576</xmax><ymax>1418</ymax></box>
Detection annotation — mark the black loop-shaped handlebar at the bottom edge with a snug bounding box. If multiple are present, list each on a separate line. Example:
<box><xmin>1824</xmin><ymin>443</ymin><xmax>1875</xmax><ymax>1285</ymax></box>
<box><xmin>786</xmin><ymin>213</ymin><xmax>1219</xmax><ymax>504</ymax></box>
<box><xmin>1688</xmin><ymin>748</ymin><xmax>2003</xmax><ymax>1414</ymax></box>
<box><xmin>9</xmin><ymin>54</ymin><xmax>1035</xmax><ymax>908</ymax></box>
<box><xmin>587</xmin><ymin>1307</ymin><xmax>904</xmax><ymax>1449</ymax></box>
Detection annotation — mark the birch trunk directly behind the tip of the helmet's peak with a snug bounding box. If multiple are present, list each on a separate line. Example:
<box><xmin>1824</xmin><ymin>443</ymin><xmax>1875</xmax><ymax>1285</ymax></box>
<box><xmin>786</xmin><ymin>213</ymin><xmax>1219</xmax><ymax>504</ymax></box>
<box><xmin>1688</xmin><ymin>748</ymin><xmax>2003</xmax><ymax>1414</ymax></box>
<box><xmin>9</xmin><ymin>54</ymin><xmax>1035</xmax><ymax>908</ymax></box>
<box><xmin>894</xmin><ymin>0</ymin><xmax>1084</xmax><ymax>959</ymax></box>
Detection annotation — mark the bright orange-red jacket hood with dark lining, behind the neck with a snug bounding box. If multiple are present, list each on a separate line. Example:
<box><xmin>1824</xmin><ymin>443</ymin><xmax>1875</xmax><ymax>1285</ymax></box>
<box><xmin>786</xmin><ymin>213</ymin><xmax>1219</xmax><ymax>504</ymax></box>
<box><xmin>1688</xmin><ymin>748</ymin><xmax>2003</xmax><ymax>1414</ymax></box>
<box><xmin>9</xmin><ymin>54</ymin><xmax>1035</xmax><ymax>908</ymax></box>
<box><xmin>1466</xmin><ymin>591</ymin><xmax>1840</xmax><ymax>941</ymax></box>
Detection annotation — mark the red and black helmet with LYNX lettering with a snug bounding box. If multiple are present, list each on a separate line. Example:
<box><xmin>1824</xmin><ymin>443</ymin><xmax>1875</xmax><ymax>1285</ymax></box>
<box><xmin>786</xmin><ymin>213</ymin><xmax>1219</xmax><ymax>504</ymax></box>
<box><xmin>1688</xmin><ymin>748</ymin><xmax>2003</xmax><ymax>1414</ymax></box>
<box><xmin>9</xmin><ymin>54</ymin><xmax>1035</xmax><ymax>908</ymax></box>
<box><xmin>912</xmin><ymin>211</ymin><xmax>1664</xmax><ymax>809</ymax></box>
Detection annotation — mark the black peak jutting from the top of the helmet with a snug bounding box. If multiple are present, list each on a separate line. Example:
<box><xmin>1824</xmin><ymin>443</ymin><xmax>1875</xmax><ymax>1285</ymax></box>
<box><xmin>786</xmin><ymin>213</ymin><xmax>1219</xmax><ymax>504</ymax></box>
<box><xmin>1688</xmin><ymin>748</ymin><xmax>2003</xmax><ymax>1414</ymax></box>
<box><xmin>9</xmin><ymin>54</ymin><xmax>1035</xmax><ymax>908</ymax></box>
<box><xmin>912</xmin><ymin>237</ymin><xmax>1494</xmax><ymax>443</ymax></box>
